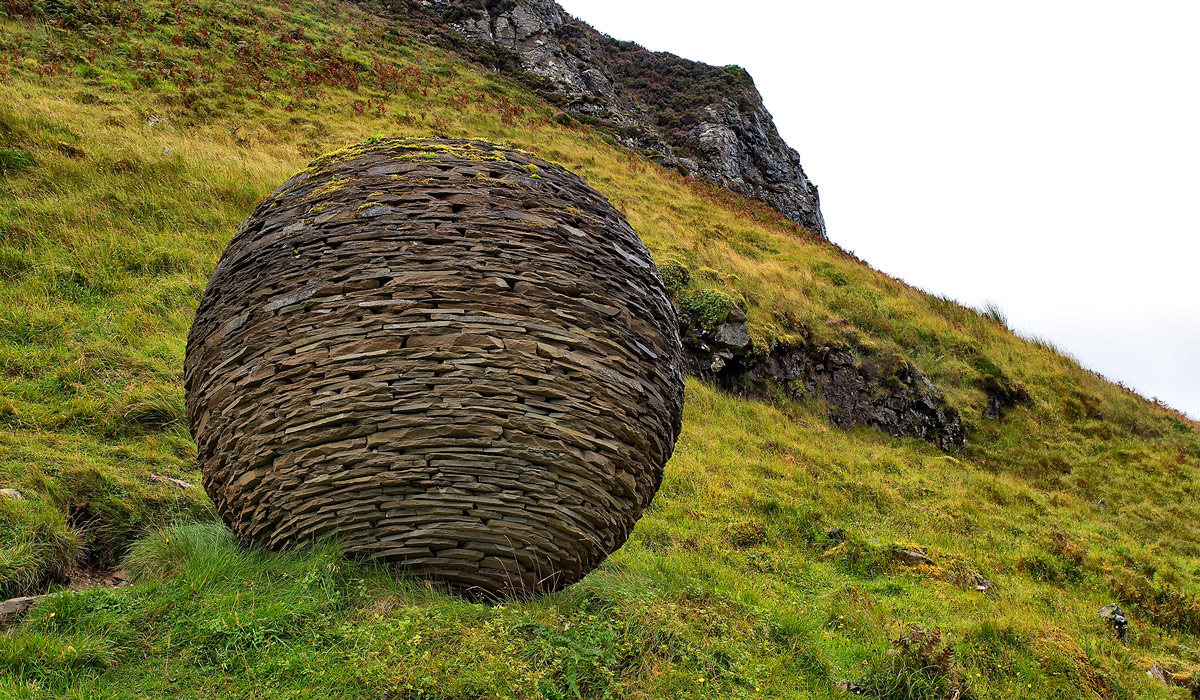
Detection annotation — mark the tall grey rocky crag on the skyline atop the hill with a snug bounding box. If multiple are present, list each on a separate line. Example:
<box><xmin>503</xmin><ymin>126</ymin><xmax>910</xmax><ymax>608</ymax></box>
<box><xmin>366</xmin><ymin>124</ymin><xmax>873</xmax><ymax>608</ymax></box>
<box><xmin>431</xmin><ymin>0</ymin><xmax>826</xmax><ymax>237</ymax></box>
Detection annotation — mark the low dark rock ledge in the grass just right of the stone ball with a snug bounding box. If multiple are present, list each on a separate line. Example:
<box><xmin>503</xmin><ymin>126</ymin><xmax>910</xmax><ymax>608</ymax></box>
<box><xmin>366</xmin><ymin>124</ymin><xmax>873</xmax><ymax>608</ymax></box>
<box><xmin>677</xmin><ymin>294</ymin><xmax>965</xmax><ymax>450</ymax></box>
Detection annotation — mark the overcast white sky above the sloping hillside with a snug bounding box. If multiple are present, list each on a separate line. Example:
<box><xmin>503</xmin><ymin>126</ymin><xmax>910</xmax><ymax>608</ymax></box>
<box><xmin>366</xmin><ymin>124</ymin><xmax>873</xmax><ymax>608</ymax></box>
<box><xmin>559</xmin><ymin>0</ymin><xmax>1200</xmax><ymax>417</ymax></box>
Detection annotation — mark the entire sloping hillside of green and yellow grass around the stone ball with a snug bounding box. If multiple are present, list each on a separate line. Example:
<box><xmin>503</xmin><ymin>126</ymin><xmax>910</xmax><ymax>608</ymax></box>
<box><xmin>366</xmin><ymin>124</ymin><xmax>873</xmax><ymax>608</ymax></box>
<box><xmin>0</xmin><ymin>0</ymin><xmax>1200</xmax><ymax>699</ymax></box>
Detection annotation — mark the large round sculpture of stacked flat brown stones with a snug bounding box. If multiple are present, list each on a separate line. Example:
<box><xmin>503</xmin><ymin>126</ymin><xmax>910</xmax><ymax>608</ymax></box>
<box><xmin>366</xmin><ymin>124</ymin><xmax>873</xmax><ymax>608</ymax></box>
<box><xmin>185</xmin><ymin>139</ymin><xmax>683</xmax><ymax>597</ymax></box>
